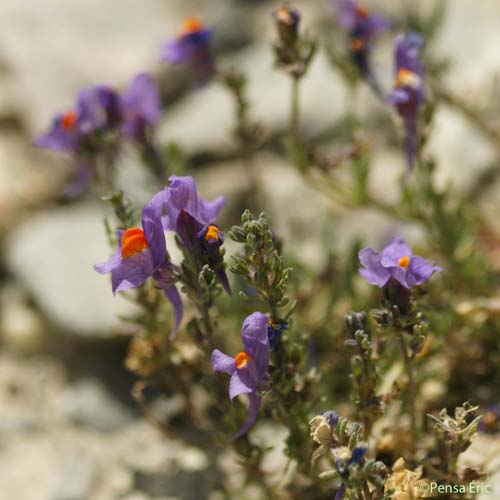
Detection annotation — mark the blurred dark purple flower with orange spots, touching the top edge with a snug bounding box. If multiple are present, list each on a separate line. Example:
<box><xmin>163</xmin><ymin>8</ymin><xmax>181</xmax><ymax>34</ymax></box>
<box><xmin>336</xmin><ymin>0</ymin><xmax>391</xmax><ymax>95</ymax></box>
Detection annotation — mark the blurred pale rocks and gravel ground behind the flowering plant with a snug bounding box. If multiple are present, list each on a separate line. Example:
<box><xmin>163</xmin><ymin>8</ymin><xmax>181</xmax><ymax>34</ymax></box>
<box><xmin>0</xmin><ymin>0</ymin><xmax>500</xmax><ymax>500</ymax></box>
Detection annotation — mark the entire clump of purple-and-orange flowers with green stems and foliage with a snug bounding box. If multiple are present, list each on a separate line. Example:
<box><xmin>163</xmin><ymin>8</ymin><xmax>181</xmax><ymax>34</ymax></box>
<box><xmin>35</xmin><ymin>0</ymin><xmax>500</xmax><ymax>500</ymax></box>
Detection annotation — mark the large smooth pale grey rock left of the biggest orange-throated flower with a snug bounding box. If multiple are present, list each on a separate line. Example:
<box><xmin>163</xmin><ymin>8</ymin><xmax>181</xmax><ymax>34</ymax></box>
<box><xmin>6</xmin><ymin>204</ymin><xmax>139</xmax><ymax>337</ymax></box>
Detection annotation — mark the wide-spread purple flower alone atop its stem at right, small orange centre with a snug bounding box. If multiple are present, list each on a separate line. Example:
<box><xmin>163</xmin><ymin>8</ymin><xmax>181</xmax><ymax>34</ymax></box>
<box><xmin>359</xmin><ymin>238</ymin><xmax>442</xmax><ymax>289</ymax></box>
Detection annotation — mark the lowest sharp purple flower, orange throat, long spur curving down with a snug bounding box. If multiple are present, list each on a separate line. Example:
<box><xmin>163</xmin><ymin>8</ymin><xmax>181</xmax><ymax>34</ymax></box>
<box><xmin>211</xmin><ymin>312</ymin><xmax>269</xmax><ymax>440</ymax></box>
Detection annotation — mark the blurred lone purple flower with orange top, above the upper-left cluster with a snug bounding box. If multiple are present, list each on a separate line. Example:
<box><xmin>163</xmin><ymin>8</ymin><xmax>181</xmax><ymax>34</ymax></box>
<box><xmin>162</xmin><ymin>17</ymin><xmax>214</xmax><ymax>86</ymax></box>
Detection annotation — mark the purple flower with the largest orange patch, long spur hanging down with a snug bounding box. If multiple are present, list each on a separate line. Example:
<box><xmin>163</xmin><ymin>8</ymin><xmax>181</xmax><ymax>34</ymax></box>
<box><xmin>94</xmin><ymin>197</ymin><xmax>183</xmax><ymax>337</ymax></box>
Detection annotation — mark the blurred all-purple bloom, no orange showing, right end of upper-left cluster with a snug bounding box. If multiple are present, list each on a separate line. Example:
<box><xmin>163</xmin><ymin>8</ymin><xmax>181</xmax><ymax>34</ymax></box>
<box><xmin>120</xmin><ymin>73</ymin><xmax>162</xmax><ymax>141</ymax></box>
